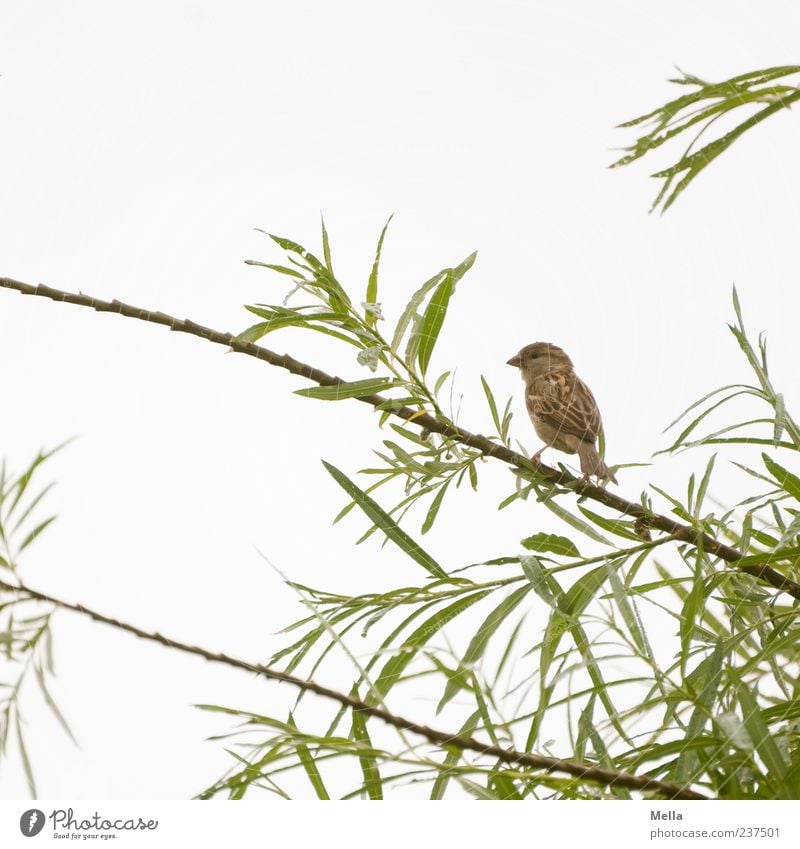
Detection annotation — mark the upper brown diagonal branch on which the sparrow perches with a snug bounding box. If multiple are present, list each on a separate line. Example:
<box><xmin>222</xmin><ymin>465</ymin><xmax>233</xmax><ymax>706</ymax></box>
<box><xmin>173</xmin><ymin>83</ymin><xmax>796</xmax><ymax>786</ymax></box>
<box><xmin>0</xmin><ymin>277</ymin><xmax>800</xmax><ymax>599</ymax></box>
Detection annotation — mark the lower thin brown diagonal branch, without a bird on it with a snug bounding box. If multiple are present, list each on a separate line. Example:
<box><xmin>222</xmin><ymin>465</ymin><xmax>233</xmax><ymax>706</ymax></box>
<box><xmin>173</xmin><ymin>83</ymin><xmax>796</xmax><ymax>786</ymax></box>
<box><xmin>0</xmin><ymin>581</ymin><xmax>708</xmax><ymax>800</ymax></box>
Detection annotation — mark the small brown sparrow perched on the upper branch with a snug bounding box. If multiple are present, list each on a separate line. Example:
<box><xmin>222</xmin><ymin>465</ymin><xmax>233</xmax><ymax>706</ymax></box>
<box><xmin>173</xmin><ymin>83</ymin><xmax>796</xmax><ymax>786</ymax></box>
<box><xmin>508</xmin><ymin>342</ymin><xmax>617</xmax><ymax>483</ymax></box>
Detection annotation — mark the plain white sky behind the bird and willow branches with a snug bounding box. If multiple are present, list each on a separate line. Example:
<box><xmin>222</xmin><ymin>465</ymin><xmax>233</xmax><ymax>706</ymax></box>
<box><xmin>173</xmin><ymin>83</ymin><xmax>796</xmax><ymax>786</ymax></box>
<box><xmin>0</xmin><ymin>0</ymin><xmax>800</xmax><ymax>798</ymax></box>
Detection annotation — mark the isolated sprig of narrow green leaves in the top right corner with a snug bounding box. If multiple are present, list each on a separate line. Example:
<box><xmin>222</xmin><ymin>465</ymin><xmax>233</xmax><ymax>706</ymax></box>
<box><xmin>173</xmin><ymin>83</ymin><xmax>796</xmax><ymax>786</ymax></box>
<box><xmin>611</xmin><ymin>65</ymin><xmax>800</xmax><ymax>212</ymax></box>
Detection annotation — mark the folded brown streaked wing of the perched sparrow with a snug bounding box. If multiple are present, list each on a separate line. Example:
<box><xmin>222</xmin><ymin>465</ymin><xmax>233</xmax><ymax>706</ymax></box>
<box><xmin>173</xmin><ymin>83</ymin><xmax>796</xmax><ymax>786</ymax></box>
<box><xmin>526</xmin><ymin>372</ymin><xmax>602</xmax><ymax>442</ymax></box>
